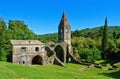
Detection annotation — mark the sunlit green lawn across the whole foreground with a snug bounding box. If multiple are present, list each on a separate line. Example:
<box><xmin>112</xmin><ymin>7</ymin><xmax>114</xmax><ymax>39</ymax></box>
<box><xmin>0</xmin><ymin>62</ymin><xmax>120</xmax><ymax>79</ymax></box>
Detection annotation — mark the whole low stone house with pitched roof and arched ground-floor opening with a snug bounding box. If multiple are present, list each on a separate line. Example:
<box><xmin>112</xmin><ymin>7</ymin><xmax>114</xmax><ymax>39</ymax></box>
<box><xmin>11</xmin><ymin>40</ymin><xmax>48</xmax><ymax>65</ymax></box>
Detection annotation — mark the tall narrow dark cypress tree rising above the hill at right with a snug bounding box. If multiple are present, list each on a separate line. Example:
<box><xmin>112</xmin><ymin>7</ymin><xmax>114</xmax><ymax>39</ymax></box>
<box><xmin>102</xmin><ymin>17</ymin><xmax>108</xmax><ymax>59</ymax></box>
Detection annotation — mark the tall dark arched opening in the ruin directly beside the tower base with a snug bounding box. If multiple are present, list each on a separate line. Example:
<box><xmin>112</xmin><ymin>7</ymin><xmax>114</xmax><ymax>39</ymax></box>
<box><xmin>55</xmin><ymin>45</ymin><xmax>64</xmax><ymax>62</ymax></box>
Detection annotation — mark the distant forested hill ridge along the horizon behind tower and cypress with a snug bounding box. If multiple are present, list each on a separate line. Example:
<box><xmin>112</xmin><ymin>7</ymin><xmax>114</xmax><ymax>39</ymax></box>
<box><xmin>39</xmin><ymin>26</ymin><xmax>120</xmax><ymax>43</ymax></box>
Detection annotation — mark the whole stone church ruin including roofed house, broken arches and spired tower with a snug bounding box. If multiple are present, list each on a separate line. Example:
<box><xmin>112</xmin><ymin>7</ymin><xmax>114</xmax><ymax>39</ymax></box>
<box><xmin>11</xmin><ymin>13</ymin><xmax>79</xmax><ymax>66</ymax></box>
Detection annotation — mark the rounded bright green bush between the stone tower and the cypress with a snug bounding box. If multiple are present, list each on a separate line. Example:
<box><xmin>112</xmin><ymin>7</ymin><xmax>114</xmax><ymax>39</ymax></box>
<box><xmin>79</xmin><ymin>47</ymin><xmax>101</xmax><ymax>62</ymax></box>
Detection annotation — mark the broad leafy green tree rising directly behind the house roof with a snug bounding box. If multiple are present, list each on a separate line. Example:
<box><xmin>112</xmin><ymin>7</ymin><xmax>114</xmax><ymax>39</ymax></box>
<box><xmin>8</xmin><ymin>20</ymin><xmax>37</xmax><ymax>40</ymax></box>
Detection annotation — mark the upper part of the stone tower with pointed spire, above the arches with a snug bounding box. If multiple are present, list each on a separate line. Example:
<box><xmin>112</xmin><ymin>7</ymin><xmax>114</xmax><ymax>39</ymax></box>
<box><xmin>58</xmin><ymin>13</ymin><xmax>71</xmax><ymax>46</ymax></box>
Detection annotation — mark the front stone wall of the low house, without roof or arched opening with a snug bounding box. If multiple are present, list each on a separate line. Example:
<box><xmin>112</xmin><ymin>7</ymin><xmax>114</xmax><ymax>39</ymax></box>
<box><xmin>12</xmin><ymin>45</ymin><xmax>47</xmax><ymax>65</ymax></box>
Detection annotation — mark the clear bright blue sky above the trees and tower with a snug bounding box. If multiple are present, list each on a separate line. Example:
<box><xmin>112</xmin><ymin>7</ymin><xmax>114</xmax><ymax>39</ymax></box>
<box><xmin>0</xmin><ymin>0</ymin><xmax>120</xmax><ymax>34</ymax></box>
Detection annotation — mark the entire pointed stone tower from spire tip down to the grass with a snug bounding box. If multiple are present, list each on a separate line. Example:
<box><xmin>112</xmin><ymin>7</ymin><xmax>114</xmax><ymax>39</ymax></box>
<box><xmin>56</xmin><ymin>13</ymin><xmax>72</xmax><ymax>62</ymax></box>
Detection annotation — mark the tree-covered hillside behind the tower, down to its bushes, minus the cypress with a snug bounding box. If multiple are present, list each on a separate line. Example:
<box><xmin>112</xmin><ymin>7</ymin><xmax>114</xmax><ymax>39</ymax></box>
<box><xmin>39</xmin><ymin>26</ymin><xmax>120</xmax><ymax>62</ymax></box>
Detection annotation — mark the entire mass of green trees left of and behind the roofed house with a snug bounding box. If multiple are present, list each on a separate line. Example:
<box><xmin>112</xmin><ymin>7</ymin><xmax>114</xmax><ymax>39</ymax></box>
<box><xmin>0</xmin><ymin>18</ymin><xmax>37</xmax><ymax>61</ymax></box>
